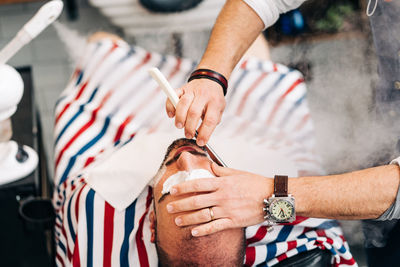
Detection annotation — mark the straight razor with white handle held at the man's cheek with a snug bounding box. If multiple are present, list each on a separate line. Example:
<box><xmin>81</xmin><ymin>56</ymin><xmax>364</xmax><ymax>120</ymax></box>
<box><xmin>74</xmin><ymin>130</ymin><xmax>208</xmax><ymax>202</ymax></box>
<box><xmin>148</xmin><ymin>68</ymin><xmax>226</xmax><ymax>167</ymax></box>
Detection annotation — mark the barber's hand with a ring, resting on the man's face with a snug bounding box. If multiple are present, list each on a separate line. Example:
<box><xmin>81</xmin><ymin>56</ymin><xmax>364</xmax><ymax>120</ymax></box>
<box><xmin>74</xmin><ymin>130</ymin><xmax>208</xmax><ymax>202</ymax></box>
<box><xmin>167</xmin><ymin>163</ymin><xmax>273</xmax><ymax>236</ymax></box>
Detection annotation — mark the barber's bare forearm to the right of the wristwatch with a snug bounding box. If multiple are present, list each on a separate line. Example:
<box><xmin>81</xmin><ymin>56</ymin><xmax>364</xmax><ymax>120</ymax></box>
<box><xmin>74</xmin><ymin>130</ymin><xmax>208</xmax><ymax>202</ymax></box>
<box><xmin>289</xmin><ymin>165</ymin><xmax>400</xmax><ymax>219</ymax></box>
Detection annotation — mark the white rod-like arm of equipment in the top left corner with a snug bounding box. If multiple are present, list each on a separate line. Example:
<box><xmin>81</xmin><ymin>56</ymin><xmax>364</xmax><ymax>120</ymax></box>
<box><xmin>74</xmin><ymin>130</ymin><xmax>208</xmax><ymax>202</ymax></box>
<box><xmin>0</xmin><ymin>0</ymin><xmax>64</xmax><ymax>64</ymax></box>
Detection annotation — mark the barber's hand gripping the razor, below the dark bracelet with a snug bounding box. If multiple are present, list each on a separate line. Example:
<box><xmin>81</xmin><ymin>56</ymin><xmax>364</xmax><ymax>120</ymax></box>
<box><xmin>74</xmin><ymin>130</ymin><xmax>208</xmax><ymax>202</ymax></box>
<box><xmin>166</xmin><ymin>79</ymin><xmax>225</xmax><ymax>146</ymax></box>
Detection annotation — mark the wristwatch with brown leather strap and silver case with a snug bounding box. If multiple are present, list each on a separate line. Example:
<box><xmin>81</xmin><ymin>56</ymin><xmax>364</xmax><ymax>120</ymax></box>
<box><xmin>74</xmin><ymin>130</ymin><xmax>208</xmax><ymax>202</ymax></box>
<box><xmin>263</xmin><ymin>175</ymin><xmax>296</xmax><ymax>225</ymax></box>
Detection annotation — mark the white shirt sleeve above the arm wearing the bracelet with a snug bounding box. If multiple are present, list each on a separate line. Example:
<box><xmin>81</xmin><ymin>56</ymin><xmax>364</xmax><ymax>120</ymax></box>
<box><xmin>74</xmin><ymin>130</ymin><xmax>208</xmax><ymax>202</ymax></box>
<box><xmin>243</xmin><ymin>0</ymin><xmax>306</xmax><ymax>29</ymax></box>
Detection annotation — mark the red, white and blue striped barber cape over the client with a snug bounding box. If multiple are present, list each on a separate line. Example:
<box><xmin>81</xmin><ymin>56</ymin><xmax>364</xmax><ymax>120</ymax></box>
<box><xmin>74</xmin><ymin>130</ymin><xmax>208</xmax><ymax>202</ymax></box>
<box><xmin>53</xmin><ymin>39</ymin><xmax>357</xmax><ymax>267</ymax></box>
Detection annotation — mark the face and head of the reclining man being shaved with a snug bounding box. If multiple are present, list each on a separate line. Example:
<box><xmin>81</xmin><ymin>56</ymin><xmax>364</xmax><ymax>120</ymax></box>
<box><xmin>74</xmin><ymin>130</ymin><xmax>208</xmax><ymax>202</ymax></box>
<box><xmin>150</xmin><ymin>139</ymin><xmax>245</xmax><ymax>266</ymax></box>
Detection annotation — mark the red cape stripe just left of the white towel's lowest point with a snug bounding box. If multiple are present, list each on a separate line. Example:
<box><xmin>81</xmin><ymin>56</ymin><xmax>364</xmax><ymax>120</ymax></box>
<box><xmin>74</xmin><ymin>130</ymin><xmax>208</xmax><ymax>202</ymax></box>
<box><xmin>103</xmin><ymin>202</ymin><xmax>115</xmax><ymax>267</ymax></box>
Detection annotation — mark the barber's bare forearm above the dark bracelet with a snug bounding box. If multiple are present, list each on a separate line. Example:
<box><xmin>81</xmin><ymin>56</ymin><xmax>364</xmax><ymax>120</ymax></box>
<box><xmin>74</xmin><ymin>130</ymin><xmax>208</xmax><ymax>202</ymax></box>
<box><xmin>198</xmin><ymin>0</ymin><xmax>264</xmax><ymax>78</ymax></box>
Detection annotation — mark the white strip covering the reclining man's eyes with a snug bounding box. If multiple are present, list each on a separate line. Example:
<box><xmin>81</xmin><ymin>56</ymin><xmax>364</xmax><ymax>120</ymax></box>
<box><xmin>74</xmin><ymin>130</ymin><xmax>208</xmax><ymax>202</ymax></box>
<box><xmin>161</xmin><ymin>169</ymin><xmax>215</xmax><ymax>195</ymax></box>
